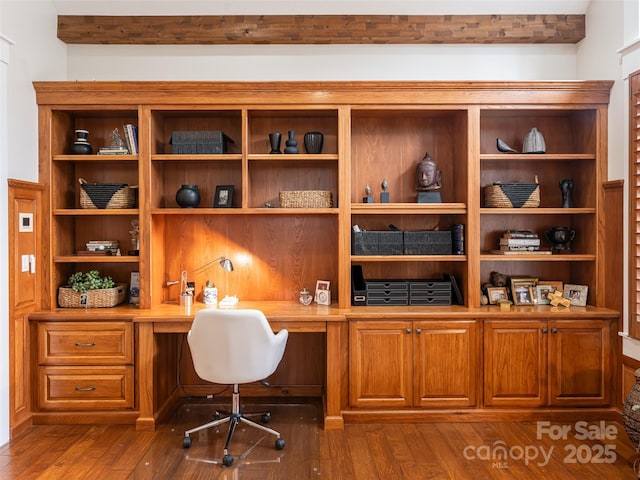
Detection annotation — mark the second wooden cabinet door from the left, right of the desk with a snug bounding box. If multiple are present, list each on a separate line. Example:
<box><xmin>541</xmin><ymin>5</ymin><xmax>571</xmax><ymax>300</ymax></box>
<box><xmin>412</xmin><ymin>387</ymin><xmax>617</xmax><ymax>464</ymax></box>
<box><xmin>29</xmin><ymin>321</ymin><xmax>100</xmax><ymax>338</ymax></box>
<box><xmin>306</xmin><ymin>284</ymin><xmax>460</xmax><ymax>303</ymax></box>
<box><xmin>413</xmin><ymin>320</ymin><xmax>480</xmax><ymax>407</ymax></box>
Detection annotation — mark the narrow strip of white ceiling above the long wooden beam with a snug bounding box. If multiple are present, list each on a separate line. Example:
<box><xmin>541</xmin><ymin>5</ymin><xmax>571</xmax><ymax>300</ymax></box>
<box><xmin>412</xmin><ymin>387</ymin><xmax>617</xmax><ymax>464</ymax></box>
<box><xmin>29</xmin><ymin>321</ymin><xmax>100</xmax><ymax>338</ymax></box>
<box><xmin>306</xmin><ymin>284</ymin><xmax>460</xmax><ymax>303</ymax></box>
<box><xmin>52</xmin><ymin>0</ymin><xmax>592</xmax><ymax>15</ymax></box>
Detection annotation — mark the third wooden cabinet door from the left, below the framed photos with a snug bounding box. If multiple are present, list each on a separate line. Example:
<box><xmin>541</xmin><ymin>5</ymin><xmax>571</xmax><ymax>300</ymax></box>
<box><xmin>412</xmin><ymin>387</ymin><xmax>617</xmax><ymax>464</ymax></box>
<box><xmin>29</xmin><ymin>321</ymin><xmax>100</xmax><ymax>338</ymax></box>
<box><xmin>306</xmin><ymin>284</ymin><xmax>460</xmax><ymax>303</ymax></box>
<box><xmin>484</xmin><ymin>320</ymin><xmax>548</xmax><ymax>407</ymax></box>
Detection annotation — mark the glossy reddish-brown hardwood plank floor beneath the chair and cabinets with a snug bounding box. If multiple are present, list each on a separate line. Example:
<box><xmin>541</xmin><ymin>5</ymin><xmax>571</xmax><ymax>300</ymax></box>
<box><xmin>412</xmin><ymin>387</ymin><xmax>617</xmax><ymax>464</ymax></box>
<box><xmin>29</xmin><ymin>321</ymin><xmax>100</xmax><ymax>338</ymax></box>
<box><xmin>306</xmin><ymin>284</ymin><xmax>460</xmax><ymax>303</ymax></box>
<box><xmin>0</xmin><ymin>401</ymin><xmax>638</xmax><ymax>480</ymax></box>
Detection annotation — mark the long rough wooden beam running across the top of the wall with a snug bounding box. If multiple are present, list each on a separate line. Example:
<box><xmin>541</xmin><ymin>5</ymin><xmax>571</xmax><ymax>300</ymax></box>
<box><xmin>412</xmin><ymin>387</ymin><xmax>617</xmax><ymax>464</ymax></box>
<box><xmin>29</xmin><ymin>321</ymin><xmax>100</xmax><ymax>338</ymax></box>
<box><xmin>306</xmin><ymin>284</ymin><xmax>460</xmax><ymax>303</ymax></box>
<box><xmin>58</xmin><ymin>15</ymin><xmax>585</xmax><ymax>45</ymax></box>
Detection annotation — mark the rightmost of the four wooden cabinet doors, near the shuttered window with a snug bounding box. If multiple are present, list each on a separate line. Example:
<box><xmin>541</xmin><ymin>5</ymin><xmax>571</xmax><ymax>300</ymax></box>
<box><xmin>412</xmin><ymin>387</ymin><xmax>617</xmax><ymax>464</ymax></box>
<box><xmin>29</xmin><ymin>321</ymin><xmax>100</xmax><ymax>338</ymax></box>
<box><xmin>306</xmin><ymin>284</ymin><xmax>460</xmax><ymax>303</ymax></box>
<box><xmin>549</xmin><ymin>320</ymin><xmax>613</xmax><ymax>406</ymax></box>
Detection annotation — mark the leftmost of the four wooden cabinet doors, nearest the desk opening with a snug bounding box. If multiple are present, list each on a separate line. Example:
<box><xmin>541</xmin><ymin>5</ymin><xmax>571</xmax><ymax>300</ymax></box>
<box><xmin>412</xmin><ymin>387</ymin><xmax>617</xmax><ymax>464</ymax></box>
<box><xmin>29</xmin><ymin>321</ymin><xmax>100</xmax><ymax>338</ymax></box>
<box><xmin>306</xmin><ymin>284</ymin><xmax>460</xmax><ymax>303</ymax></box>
<box><xmin>349</xmin><ymin>321</ymin><xmax>413</xmax><ymax>407</ymax></box>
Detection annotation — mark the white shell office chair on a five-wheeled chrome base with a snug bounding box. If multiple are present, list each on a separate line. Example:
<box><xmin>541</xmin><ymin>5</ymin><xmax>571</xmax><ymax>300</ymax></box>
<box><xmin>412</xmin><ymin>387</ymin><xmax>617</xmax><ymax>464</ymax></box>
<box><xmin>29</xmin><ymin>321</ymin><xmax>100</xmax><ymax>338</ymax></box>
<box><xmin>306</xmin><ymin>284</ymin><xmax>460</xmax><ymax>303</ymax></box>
<box><xmin>182</xmin><ymin>309</ymin><xmax>289</xmax><ymax>466</ymax></box>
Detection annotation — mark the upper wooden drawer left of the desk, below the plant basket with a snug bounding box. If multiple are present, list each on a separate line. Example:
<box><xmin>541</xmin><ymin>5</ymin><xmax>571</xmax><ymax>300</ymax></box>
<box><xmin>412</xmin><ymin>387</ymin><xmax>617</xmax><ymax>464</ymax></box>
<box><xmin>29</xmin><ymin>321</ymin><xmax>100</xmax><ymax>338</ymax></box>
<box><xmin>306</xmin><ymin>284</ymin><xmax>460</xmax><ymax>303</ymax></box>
<box><xmin>38</xmin><ymin>322</ymin><xmax>133</xmax><ymax>365</ymax></box>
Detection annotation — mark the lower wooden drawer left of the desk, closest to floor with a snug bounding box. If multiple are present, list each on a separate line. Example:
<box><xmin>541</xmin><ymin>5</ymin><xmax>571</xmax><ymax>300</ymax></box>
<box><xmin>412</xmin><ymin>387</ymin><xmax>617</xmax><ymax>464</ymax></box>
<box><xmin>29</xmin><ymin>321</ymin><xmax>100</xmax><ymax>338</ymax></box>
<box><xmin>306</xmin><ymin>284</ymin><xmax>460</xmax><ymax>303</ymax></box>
<box><xmin>38</xmin><ymin>366</ymin><xmax>134</xmax><ymax>410</ymax></box>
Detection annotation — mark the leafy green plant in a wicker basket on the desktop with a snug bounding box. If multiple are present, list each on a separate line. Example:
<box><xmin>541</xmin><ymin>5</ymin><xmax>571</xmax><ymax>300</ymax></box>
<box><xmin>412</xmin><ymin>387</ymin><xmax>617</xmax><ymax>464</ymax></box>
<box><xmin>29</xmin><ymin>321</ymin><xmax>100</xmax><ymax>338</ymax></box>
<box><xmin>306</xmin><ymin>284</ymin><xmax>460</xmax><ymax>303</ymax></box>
<box><xmin>58</xmin><ymin>270</ymin><xmax>126</xmax><ymax>308</ymax></box>
